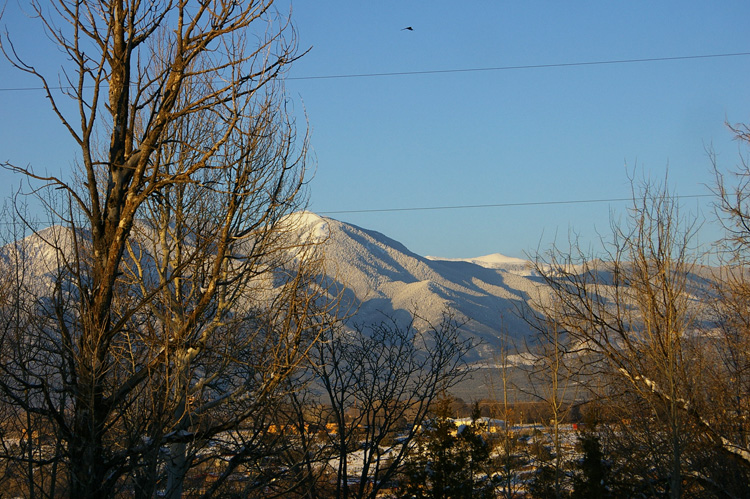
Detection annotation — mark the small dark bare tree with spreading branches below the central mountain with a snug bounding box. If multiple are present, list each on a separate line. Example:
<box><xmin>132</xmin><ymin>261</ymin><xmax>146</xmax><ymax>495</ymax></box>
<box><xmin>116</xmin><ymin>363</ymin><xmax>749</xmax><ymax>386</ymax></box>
<box><xmin>288</xmin><ymin>313</ymin><xmax>471</xmax><ymax>498</ymax></box>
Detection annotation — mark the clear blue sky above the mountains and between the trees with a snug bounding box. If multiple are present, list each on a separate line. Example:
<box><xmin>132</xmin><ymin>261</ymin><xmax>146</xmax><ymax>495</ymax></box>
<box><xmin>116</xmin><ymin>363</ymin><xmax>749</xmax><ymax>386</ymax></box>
<box><xmin>0</xmin><ymin>0</ymin><xmax>750</xmax><ymax>257</ymax></box>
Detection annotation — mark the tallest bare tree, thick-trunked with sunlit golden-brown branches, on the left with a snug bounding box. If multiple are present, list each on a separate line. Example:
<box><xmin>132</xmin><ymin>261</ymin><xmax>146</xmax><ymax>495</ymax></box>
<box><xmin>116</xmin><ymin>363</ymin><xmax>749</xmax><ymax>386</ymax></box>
<box><xmin>2</xmin><ymin>0</ymin><xmax>319</xmax><ymax>497</ymax></box>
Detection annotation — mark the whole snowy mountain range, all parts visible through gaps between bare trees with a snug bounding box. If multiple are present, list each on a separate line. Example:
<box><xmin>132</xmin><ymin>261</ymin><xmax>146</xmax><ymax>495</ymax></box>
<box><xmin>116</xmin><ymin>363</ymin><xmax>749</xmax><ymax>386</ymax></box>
<box><xmin>0</xmin><ymin>212</ymin><xmax>712</xmax><ymax>365</ymax></box>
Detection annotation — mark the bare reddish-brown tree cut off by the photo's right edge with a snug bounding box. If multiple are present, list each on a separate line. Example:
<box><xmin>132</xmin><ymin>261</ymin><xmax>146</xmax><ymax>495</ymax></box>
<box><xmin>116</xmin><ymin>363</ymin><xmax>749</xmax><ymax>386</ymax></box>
<box><xmin>704</xmin><ymin>124</ymin><xmax>750</xmax><ymax>483</ymax></box>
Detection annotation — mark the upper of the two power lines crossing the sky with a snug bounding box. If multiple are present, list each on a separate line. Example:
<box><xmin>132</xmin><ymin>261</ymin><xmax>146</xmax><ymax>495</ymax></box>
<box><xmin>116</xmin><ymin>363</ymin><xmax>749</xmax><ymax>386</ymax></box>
<box><xmin>0</xmin><ymin>52</ymin><xmax>750</xmax><ymax>92</ymax></box>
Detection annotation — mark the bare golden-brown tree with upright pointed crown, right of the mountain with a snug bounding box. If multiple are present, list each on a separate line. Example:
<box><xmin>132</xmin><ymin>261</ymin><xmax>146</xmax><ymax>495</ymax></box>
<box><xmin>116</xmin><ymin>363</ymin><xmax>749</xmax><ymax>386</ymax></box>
<box><xmin>536</xmin><ymin>178</ymin><xmax>701</xmax><ymax>497</ymax></box>
